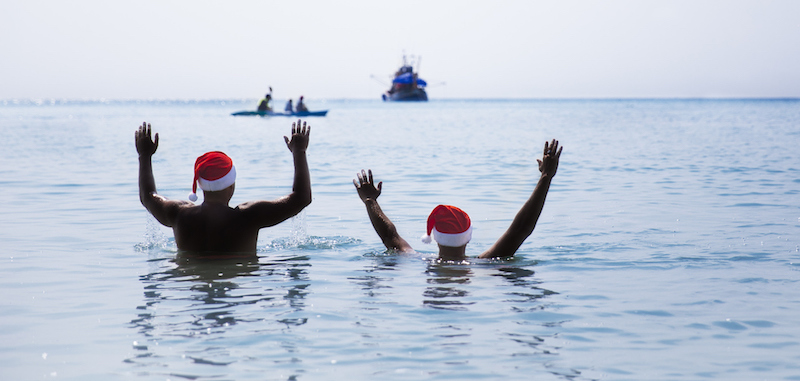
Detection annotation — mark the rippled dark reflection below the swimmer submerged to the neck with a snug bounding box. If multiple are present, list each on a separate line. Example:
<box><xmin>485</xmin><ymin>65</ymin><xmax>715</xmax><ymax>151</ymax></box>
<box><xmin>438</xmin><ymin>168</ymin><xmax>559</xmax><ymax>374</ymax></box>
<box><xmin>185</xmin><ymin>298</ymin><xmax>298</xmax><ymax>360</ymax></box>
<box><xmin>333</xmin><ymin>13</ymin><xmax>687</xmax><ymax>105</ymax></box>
<box><xmin>349</xmin><ymin>254</ymin><xmax>583</xmax><ymax>379</ymax></box>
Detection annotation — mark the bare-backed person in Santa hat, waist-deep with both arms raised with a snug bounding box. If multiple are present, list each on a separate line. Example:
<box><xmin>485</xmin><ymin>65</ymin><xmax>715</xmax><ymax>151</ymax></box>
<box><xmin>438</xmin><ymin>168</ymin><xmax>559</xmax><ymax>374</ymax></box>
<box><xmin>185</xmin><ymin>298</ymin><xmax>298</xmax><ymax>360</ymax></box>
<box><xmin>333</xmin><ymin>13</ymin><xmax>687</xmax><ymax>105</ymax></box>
<box><xmin>135</xmin><ymin>120</ymin><xmax>311</xmax><ymax>257</ymax></box>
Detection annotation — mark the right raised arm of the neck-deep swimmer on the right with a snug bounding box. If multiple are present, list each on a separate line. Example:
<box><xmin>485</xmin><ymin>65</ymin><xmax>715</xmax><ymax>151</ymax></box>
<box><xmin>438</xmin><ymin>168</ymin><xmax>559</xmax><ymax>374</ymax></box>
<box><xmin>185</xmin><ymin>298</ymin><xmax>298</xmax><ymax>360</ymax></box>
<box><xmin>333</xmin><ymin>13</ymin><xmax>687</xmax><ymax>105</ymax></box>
<box><xmin>479</xmin><ymin>139</ymin><xmax>563</xmax><ymax>258</ymax></box>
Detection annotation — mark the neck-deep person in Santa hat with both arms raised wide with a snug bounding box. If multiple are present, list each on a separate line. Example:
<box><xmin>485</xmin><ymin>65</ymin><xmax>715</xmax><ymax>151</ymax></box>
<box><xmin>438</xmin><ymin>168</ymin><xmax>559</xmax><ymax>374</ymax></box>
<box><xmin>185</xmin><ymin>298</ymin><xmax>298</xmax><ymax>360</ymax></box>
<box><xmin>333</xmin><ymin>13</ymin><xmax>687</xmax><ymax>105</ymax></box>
<box><xmin>353</xmin><ymin>139</ymin><xmax>563</xmax><ymax>262</ymax></box>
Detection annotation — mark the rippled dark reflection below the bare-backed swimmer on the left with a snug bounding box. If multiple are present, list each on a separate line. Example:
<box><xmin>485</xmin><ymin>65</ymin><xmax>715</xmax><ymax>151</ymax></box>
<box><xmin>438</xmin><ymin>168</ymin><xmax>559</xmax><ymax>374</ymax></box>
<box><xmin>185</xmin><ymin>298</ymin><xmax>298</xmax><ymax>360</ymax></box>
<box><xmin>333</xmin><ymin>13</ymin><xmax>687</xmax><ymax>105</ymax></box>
<box><xmin>126</xmin><ymin>251</ymin><xmax>311</xmax><ymax>379</ymax></box>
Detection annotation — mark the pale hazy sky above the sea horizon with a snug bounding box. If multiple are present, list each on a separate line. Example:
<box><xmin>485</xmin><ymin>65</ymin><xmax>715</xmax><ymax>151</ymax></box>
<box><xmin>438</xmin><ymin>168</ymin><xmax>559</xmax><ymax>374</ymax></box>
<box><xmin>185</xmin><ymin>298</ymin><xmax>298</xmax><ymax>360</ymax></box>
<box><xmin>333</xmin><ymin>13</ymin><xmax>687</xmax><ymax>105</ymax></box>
<box><xmin>0</xmin><ymin>0</ymin><xmax>800</xmax><ymax>99</ymax></box>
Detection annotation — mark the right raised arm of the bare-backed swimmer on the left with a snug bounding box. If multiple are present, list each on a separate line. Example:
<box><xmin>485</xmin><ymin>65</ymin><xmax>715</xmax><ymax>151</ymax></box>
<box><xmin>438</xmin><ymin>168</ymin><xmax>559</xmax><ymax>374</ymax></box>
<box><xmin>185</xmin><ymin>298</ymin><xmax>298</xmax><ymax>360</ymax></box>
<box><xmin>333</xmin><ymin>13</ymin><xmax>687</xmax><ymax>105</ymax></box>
<box><xmin>238</xmin><ymin>120</ymin><xmax>311</xmax><ymax>227</ymax></box>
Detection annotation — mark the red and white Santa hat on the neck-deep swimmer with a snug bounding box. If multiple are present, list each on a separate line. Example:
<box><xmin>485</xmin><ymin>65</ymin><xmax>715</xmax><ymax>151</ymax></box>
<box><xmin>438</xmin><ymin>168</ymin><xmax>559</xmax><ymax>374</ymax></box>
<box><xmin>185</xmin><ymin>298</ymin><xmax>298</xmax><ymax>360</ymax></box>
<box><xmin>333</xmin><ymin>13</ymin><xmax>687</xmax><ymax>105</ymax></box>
<box><xmin>422</xmin><ymin>205</ymin><xmax>472</xmax><ymax>247</ymax></box>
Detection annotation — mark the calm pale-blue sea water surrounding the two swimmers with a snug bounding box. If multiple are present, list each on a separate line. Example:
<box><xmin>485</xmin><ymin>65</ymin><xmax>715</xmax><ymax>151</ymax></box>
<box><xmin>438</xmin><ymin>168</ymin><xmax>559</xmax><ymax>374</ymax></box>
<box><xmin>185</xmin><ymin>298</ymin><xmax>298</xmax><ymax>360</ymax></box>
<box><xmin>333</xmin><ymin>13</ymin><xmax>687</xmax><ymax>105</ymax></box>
<box><xmin>0</xmin><ymin>100</ymin><xmax>800</xmax><ymax>380</ymax></box>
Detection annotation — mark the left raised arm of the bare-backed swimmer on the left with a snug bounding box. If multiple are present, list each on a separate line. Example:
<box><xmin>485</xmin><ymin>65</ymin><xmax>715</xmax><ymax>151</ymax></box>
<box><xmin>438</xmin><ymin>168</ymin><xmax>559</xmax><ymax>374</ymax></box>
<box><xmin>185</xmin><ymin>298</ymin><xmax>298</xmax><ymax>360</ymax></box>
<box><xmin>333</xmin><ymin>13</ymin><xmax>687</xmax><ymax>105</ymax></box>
<box><xmin>134</xmin><ymin>122</ymin><xmax>191</xmax><ymax>226</ymax></box>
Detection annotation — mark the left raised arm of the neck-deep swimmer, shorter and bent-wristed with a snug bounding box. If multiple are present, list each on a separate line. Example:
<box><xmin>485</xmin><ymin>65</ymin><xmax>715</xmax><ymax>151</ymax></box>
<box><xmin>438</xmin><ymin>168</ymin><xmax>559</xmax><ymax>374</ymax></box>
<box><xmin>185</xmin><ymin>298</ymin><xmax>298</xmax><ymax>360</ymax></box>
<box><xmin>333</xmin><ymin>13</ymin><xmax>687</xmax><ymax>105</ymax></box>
<box><xmin>353</xmin><ymin>169</ymin><xmax>414</xmax><ymax>252</ymax></box>
